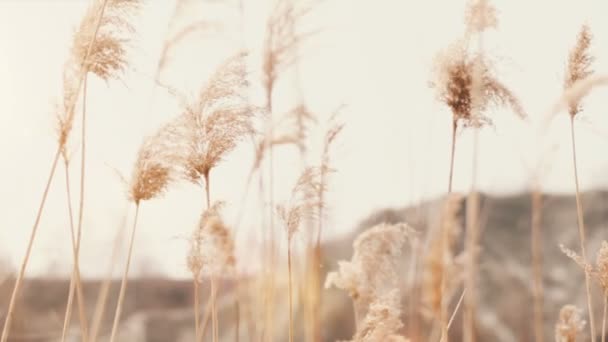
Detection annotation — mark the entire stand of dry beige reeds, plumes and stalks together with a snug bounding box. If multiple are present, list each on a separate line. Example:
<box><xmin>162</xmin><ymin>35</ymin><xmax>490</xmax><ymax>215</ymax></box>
<box><xmin>0</xmin><ymin>0</ymin><xmax>608</xmax><ymax>342</ymax></box>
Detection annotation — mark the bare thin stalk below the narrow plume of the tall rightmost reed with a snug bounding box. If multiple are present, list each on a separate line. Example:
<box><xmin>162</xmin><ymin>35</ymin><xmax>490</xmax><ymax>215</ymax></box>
<box><xmin>570</xmin><ymin>115</ymin><xmax>595</xmax><ymax>342</ymax></box>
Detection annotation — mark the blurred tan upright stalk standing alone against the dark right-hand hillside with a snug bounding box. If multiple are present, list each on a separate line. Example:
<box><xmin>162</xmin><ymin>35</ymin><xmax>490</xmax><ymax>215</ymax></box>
<box><xmin>532</xmin><ymin>187</ymin><xmax>544</xmax><ymax>342</ymax></box>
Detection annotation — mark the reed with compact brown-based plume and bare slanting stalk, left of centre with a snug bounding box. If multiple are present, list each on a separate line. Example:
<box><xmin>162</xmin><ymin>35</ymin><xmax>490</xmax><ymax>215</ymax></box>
<box><xmin>110</xmin><ymin>123</ymin><xmax>181</xmax><ymax>342</ymax></box>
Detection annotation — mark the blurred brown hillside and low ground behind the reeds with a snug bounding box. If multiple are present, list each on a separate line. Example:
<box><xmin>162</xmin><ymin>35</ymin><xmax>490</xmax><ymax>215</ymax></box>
<box><xmin>0</xmin><ymin>191</ymin><xmax>608</xmax><ymax>342</ymax></box>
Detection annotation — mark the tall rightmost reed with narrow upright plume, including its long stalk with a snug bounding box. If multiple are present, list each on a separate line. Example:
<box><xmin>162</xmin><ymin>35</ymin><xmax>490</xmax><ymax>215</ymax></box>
<box><xmin>564</xmin><ymin>25</ymin><xmax>595</xmax><ymax>342</ymax></box>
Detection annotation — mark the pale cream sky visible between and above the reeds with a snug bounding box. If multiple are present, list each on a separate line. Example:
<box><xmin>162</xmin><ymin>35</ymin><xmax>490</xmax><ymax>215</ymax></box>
<box><xmin>0</xmin><ymin>0</ymin><xmax>608</xmax><ymax>277</ymax></box>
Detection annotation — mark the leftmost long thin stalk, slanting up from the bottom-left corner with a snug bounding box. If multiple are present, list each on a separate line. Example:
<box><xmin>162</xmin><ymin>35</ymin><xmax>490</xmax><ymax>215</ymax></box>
<box><xmin>0</xmin><ymin>146</ymin><xmax>61</xmax><ymax>342</ymax></box>
